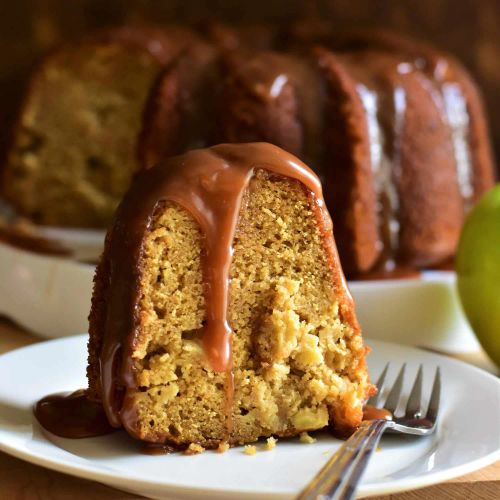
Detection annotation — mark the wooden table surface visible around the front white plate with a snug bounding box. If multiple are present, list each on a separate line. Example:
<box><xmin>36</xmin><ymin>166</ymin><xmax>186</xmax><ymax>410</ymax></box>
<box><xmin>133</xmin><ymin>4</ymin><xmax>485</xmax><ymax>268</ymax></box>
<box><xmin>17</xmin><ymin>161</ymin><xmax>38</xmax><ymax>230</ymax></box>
<box><xmin>0</xmin><ymin>319</ymin><xmax>500</xmax><ymax>500</ymax></box>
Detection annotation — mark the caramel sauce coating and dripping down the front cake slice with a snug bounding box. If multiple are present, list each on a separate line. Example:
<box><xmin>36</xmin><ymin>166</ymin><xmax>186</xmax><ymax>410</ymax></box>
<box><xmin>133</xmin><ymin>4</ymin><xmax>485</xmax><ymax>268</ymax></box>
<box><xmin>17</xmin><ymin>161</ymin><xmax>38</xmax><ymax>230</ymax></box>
<box><xmin>96</xmin><ymin>143</ymin><xmax>352</xmax><ymax>433</ymax></box>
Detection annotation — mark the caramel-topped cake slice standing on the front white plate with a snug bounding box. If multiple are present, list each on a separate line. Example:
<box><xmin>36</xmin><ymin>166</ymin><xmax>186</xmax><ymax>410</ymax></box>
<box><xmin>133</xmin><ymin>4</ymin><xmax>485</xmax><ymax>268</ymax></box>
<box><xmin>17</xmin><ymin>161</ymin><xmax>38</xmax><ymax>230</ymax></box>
<box><xmin>83</xmin><ymin>143</ymin><xmax>374</xmax><ymax>449</ymax></box>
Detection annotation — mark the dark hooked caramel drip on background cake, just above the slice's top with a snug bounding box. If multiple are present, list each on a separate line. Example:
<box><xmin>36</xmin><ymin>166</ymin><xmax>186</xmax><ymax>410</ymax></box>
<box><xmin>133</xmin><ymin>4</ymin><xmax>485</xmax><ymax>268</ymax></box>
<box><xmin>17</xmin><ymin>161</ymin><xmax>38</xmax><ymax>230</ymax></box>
<box><xmin>236</xmin><ymin>52</ymin><xmax>325</xmax><ymax>171</ymax></box>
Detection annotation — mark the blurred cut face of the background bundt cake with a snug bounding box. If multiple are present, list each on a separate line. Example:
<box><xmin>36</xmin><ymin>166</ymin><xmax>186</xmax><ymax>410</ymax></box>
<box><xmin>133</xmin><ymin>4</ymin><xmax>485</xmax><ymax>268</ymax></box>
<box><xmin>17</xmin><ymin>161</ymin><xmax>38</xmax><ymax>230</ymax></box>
<box><xmin>3</xmin><ymin>42</ymin><xmax>164</xmax><ymax>227</ymax></box>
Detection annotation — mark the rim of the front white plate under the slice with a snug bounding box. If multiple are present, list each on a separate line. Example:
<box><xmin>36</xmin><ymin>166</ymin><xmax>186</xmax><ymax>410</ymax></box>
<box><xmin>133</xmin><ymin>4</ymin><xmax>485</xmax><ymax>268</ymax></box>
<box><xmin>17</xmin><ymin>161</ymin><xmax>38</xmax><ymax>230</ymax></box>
<box><xmin>0</xmin><ymin>334</ymin><xmax>500</xmax><ymax>500</ymax></box>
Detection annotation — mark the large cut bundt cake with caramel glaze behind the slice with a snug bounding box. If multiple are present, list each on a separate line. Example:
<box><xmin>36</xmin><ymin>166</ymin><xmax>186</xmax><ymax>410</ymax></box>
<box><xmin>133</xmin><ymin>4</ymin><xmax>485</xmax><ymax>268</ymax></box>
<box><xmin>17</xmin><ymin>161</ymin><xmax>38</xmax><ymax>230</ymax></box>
<box><xmin>3</xmin><ymin>25</ymin><xmax>494</xmax><ymax>278</ymax></box>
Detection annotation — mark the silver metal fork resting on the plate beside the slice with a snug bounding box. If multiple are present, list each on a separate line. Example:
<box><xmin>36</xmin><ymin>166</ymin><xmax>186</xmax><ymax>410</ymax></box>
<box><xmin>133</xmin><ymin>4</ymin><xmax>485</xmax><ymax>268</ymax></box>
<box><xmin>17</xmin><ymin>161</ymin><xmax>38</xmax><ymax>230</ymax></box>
<box><xmin>297</xmin><ymin>364</ymin><xmax>441</xmax><ymax>500</ymax></box>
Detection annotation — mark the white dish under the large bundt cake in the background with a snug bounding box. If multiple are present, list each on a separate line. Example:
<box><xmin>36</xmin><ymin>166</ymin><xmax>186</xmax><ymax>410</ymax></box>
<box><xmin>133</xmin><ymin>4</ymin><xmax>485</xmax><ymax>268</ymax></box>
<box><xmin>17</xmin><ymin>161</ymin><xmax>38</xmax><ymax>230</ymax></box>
<box><xmin>0</xmin><ymin>240</ymin><xmax>480</xmax><ymax>353</ymax></box>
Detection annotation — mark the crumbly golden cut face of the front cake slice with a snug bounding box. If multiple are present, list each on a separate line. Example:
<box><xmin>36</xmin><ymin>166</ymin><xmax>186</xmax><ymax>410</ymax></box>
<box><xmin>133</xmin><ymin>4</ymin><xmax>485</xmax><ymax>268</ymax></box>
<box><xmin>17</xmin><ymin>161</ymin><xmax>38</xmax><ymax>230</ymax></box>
<box><xmin>102</xmin><ymin>170</ymin><xmax>371</xmax><ymax>447</ymax></box>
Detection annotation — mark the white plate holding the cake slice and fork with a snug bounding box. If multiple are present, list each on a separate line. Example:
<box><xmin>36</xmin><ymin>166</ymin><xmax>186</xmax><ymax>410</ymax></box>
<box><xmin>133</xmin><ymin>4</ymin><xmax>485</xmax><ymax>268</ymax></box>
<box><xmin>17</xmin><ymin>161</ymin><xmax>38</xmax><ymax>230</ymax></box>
<box><xmin>0</xmin><ymin>335</ymin><xmax>500</xmax><ymax>499</ymax></box>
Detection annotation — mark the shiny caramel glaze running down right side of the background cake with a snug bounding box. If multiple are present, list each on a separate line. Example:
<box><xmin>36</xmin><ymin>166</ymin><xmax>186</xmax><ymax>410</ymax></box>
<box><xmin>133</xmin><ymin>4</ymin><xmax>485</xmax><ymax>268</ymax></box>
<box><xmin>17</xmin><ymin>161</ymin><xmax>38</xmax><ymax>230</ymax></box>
<box><xmin>340</xmin><ymin>45</ymin><xmax>474</xmax><ymax>279</ymax></box>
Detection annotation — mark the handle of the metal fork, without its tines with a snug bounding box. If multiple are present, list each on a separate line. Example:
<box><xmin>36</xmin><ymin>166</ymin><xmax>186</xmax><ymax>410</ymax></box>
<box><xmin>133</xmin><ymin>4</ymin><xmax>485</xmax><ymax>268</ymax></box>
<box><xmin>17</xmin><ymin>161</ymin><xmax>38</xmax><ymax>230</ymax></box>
<box><xmin>296</xmin><ymin>420</ymin><xmax>390</xmax><ymax>500</ymax></box>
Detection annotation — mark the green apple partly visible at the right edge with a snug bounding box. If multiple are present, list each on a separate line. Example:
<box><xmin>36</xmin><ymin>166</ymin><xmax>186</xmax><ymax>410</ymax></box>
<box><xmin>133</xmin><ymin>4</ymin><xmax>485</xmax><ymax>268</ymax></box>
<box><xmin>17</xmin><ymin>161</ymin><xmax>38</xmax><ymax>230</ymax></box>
<box><xmin>456</xmin><ymin>184</ymin><xmax>500</xmax><ymax>367</ymax></box>
